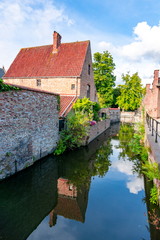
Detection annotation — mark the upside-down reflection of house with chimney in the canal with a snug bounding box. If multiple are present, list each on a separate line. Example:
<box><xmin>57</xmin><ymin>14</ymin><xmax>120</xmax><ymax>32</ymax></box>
<box><xmin>49</xmin><ymin>178</ymin><xmax>88</xmax><ymax>226</ymax></box>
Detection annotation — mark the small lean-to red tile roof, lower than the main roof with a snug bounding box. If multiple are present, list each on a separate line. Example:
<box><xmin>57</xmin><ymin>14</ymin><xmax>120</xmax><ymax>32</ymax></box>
<box><xmin>59</xmin><ymin>96</ymin><xmax>77</xmax><ymax>117</ymax></box>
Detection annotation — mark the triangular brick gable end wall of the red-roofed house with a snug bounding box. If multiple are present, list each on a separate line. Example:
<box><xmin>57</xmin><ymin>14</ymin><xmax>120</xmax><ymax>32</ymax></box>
<box><xmin>80</xmin><ymin>42</ymin><xmax>97</xmax><ymax>102</ymax></box>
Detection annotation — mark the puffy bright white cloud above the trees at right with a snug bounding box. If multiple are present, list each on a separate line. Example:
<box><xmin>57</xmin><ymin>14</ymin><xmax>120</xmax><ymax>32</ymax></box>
<box><xmin>97</xmin><ymin>22</ymin><xmax>160</xmax><ymax>84</ymax></box>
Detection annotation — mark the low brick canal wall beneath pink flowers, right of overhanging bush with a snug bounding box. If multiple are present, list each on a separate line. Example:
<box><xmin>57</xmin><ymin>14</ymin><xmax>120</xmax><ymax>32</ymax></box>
<box><xmin>84</xmin><ymin>119</ymin><xmax>110</xmax><ymax>145</ymax></box>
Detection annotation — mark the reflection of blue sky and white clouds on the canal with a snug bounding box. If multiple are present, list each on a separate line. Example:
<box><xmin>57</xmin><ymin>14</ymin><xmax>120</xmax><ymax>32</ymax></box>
<box><xmin>27</xmin><ymin>140</ymin><xmax>150</xmax><ymax>240</ymax></box>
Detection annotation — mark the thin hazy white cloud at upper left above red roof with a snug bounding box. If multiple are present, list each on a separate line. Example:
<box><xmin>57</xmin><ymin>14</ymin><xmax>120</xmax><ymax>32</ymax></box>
<box><xmin>0</xmin><ymin>0</ymin><xmax>74</xmax><ymax>68</ymax></box>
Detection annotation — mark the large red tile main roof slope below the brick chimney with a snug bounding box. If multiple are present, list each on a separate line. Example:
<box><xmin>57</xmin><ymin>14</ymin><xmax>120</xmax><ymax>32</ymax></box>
<box><xmin>4</xmin><ymin>41</ymin><xmax>89</xmax><ymax>78</ymax></box>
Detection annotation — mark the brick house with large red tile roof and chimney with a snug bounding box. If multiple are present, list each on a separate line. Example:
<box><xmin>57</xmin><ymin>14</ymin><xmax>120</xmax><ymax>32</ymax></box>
<box><xmin>3</xmin><ymin>31</ymin><xmax>97</xmax><ymax>117</ymax></box>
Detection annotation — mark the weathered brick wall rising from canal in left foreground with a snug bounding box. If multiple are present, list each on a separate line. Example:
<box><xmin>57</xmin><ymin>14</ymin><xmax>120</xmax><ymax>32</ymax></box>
<box><xmin>0</xmin><ymin>90</ymin><xmax>59</xmax><ymax>179</ymax></box>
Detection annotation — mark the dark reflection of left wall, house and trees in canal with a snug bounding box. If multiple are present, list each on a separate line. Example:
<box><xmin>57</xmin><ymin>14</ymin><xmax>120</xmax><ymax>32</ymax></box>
<box><xmin>0</xmin><ymin>125</ymin><xmax>118</xmax><ymax>240</ymax></box>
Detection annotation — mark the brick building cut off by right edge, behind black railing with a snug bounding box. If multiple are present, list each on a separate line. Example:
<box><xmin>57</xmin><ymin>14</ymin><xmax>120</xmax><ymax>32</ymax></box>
<box><xmin>143</xmin><ymin>70</ymin><xmax>160</xmax><ymax>118</ymax></box>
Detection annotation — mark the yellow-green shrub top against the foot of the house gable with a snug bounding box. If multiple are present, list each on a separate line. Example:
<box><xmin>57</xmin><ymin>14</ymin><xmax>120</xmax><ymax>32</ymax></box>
<box><xmin>73</xmin><ymin>97</ymin><xmax>100</xmax><ymax>121</ymax></box>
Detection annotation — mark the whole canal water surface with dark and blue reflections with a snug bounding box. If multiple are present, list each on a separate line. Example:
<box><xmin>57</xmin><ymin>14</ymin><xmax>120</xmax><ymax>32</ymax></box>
<box><xmin>0</xmin><ymin>124</ymin><xmax>160</xmax><ymax>240</ymax></box>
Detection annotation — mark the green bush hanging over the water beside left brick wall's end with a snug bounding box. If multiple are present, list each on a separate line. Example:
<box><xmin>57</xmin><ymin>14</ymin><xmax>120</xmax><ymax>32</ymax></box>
<box><xmin>54</xmin><ymin>112</ymin><xmax>89</xmax><ymax>155</ymax></box>
